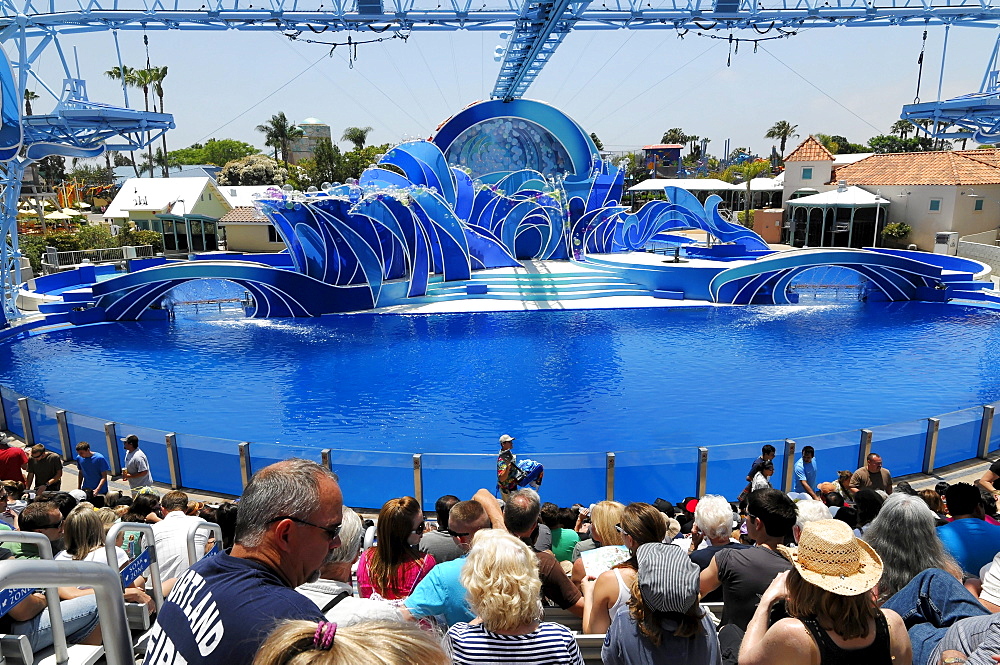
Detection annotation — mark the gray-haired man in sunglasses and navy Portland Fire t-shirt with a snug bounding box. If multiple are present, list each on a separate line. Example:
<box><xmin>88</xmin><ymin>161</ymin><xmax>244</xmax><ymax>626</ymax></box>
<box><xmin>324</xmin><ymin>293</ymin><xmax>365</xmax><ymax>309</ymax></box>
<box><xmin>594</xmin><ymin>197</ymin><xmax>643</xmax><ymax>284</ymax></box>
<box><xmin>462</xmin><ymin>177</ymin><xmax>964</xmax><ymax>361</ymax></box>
<box><xmin>146</xmin><ymin>459</ymin><xmax>344</xmax><ymax>665</ymax></box>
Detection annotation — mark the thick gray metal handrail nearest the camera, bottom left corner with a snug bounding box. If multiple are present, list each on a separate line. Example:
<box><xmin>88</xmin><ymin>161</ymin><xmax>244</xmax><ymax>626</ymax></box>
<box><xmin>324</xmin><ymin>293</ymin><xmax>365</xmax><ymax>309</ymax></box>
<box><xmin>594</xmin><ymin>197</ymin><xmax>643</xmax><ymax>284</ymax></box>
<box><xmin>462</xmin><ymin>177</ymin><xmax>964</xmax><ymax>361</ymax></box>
<box><xmin>0</xmin><ymin>559</ymin><xmax>135</xmax><ymax>665</ymax></box>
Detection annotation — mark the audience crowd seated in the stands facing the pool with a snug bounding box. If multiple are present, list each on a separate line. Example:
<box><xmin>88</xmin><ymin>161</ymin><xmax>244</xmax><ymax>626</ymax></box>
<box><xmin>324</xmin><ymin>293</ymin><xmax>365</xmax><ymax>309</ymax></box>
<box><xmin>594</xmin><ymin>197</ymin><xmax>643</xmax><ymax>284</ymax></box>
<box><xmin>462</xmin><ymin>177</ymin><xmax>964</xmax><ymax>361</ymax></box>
<box><xmin>0</xmin><ymin>430</ymin><xmax>1000</xmax><ymax>665</ymax></box>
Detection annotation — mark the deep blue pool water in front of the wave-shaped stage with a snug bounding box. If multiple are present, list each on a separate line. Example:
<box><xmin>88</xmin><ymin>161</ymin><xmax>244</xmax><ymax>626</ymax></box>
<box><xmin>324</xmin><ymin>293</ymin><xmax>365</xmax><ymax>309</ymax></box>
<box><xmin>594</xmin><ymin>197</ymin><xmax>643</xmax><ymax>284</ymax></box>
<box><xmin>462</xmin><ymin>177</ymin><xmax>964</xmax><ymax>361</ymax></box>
<box><xmin>0</xmin><ymin>303</ymin><xmax>1000</xmax><ymax>453</ymax></box>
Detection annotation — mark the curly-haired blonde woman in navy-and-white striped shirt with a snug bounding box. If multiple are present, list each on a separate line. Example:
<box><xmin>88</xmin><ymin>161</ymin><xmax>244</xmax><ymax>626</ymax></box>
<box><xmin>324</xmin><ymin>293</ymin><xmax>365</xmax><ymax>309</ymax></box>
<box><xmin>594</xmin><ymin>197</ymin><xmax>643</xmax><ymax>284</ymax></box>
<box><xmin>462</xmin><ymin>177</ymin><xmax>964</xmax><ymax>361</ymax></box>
<box><xmin>447</xmin><ymin>529</ymin><xmax>583</xmax><ymax>665</ymax></box>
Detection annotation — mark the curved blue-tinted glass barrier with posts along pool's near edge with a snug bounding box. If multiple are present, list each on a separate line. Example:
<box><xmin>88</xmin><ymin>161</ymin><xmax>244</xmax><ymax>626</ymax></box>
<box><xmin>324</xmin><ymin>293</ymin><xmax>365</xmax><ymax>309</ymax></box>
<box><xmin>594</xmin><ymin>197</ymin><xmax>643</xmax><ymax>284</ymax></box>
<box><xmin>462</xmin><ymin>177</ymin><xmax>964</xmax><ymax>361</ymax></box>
<box><xmin>0</xmin><ymin>386</ymin><xmax>1000</xmax><ymax>510</ymax></box>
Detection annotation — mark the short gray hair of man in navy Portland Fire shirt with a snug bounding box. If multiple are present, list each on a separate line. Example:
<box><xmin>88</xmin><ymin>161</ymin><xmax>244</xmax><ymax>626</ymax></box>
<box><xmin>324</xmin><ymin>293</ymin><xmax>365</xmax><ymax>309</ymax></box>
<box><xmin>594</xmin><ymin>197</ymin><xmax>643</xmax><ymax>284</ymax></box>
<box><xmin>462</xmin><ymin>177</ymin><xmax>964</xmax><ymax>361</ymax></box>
<box><xmin>235</xmin><ymin>457</ymin><xmax>337</xmax><ymax>547</ymax></box>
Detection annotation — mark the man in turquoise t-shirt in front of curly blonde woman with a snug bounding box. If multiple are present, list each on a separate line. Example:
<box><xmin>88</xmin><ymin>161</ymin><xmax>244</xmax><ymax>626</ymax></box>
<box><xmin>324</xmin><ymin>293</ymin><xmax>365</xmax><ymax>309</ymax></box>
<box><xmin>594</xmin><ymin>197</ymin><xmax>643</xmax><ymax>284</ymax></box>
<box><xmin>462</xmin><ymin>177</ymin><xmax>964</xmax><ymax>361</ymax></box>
<box><xmin>403</xmin><ymin>501</ymin><xmax>490</xmax><ymax>626</ymax></box>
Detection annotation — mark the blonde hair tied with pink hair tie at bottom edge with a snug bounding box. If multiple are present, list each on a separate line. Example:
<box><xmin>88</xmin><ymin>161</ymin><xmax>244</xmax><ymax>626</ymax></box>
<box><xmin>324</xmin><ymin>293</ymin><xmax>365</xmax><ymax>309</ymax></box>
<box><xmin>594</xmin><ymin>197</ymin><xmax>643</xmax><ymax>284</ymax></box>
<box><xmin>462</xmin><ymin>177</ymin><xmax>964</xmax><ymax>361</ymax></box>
<box><xmin>253</xmin><ymin>621</ymin><xmax>451</xmax><ymax>665</ymax></box>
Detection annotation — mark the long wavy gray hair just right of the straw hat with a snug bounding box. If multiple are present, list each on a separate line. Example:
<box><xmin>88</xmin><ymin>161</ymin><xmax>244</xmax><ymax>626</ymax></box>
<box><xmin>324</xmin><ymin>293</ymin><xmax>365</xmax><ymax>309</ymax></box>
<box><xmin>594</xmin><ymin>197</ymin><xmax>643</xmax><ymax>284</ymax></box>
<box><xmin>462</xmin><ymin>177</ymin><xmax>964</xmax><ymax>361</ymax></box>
<box><xmin>863</xmin><ymin>493</ymin><xmax>961</xmax><ymax>604</ymax></box>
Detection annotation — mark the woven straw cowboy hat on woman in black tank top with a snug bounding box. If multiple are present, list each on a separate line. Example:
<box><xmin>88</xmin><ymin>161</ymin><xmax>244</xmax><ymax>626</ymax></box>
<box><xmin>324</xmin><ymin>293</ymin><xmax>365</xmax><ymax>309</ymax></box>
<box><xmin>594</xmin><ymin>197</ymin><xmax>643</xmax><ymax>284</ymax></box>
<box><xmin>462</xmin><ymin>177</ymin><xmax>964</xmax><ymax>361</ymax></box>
<box><xmin>778</xmin><ymin>520</ymin><xmax>882</xmax><ymax>596</ymax></box>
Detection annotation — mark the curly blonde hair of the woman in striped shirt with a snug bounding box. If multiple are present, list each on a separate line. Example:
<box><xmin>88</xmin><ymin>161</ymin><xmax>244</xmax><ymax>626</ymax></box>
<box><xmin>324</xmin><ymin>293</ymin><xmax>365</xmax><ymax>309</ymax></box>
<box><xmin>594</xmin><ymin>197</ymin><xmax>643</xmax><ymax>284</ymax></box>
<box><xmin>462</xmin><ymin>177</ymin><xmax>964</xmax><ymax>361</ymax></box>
<box><xmin>461</xmin><ymin>529</ymin><xmax>542</xmax><ymax>632</ymax></box>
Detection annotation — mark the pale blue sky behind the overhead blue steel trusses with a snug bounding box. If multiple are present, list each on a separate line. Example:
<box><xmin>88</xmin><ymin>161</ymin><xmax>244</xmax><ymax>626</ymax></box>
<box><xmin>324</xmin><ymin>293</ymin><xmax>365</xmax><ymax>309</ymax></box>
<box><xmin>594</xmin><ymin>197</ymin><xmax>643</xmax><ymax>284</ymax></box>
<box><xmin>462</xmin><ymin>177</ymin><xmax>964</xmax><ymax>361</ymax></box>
<box><xmin>21</xmin><ymin>19</ymin><xmax>996</xmax><ymax>161</ymax></box>
